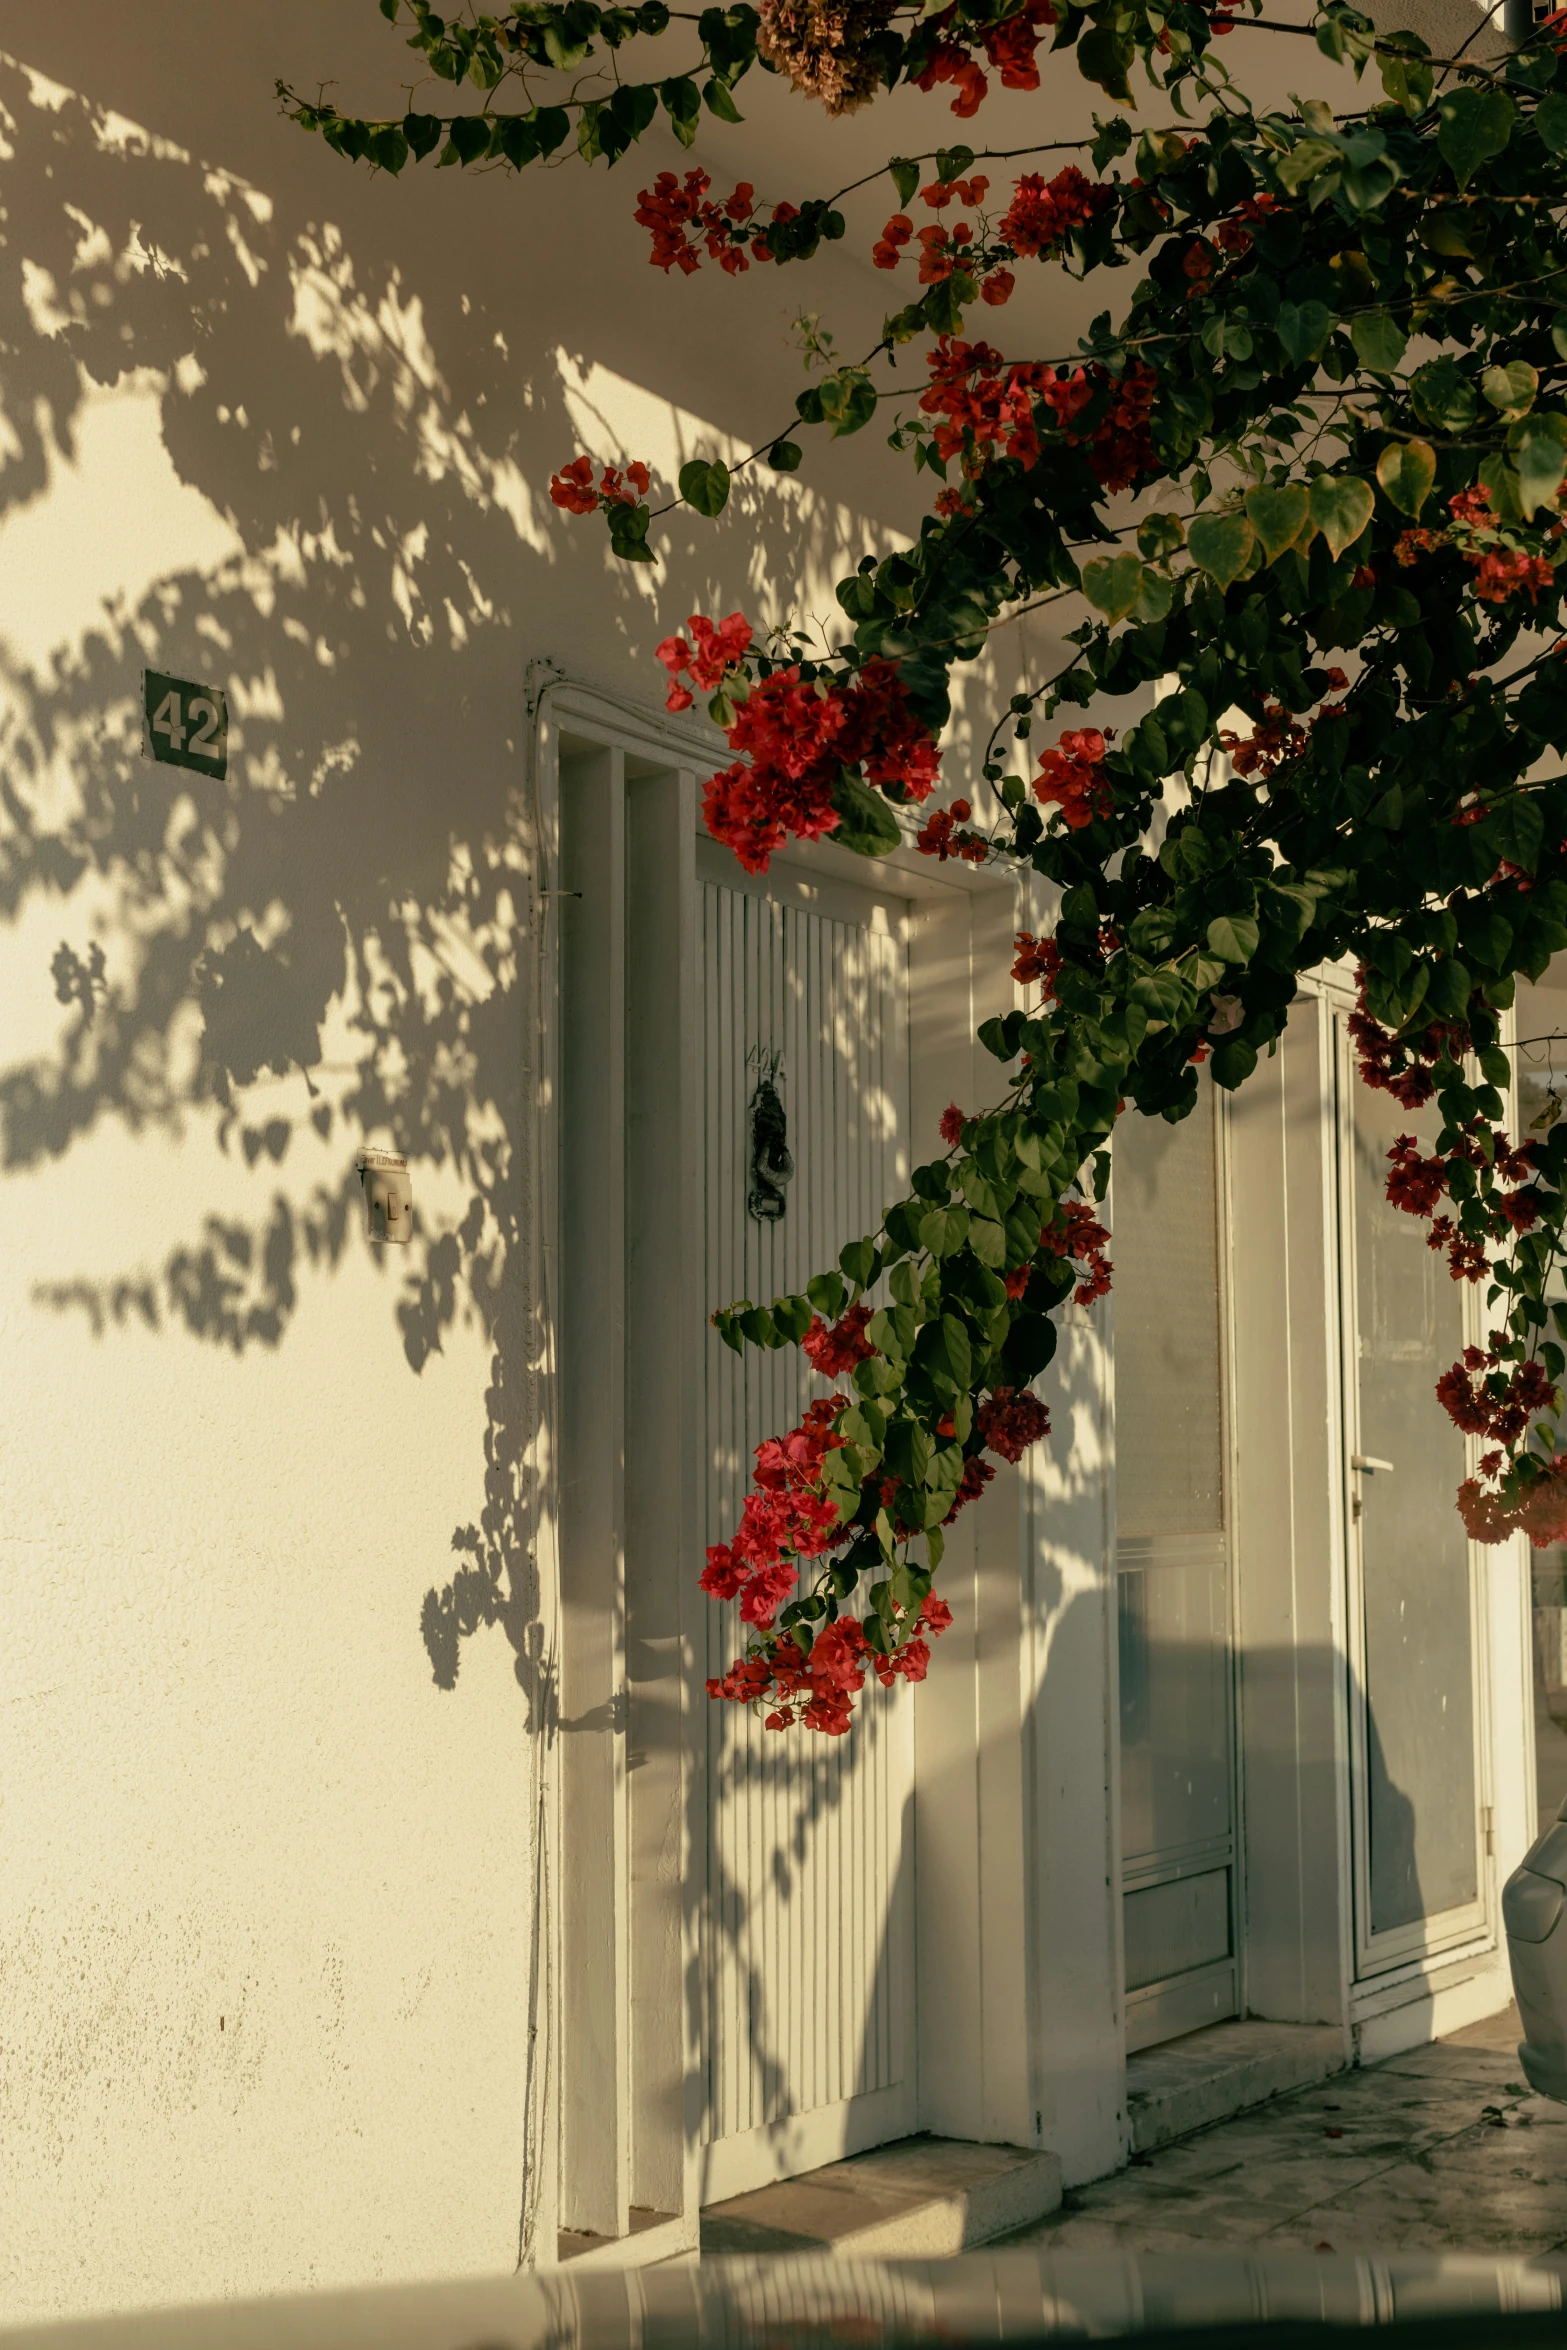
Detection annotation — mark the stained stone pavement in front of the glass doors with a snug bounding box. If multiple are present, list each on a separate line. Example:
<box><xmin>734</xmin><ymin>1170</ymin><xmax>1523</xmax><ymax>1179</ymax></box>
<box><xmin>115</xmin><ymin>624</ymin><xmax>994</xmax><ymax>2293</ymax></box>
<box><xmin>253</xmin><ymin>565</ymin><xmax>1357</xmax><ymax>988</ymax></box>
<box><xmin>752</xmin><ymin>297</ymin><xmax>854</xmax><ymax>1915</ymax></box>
<box><xmin>1006</xmin><ymin>2007</ymin><xmax>1567</xmax><ymax>2254</ymax></box>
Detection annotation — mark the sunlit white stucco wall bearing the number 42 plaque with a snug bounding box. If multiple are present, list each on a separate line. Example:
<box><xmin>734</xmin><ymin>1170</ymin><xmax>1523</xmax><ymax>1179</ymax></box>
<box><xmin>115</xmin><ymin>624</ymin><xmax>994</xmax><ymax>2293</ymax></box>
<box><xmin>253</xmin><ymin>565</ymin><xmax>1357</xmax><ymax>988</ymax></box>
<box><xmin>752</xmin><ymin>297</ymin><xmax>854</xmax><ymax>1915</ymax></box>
<box><xmin>0</xmin><ymin>0</ymin><xmax>930</xmax><ymax>2319</ymax></box>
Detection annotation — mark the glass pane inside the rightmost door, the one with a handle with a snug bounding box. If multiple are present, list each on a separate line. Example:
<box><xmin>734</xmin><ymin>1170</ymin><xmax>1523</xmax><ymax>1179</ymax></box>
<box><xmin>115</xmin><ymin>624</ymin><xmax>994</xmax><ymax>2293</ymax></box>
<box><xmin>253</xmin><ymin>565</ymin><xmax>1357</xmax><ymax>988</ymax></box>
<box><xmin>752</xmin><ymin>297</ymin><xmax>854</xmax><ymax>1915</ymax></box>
<box><xmin>1353</xmin><ymin>1079</ymin><xmax>1480</xmax><ymax>1934</ymax></box>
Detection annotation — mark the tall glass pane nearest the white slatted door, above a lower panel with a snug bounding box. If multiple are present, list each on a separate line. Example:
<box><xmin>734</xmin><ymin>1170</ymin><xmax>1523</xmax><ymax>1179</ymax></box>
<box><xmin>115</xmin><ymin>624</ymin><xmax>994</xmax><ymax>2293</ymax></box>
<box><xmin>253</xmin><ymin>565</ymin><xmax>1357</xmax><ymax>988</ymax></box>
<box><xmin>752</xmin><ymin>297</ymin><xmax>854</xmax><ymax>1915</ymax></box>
<box><xmin>1111</xmin><ymin>1088</ymin><xmax>1231</xmax><ymax>1864</ymax></box>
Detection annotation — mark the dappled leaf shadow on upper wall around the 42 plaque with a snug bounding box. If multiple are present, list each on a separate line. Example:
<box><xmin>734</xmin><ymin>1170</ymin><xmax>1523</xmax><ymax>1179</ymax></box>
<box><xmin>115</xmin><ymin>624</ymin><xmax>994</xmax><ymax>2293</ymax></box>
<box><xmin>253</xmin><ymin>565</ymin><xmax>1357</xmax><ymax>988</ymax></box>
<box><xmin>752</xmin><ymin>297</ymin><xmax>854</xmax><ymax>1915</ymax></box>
<box><xmin>0</xmin><ymin>52</ymin><xmax>843</xmax><ymax>1718</ymax></box>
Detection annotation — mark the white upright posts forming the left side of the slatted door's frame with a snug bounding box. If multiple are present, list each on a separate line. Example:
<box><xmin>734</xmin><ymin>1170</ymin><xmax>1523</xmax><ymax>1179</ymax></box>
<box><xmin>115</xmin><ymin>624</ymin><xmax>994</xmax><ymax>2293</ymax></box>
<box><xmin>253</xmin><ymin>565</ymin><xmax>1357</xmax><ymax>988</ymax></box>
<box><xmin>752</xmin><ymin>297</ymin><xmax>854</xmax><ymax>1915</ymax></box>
<box><xmin>533</xmin><ymin>684</ymin><xmax>705</xmax><ymax>2268</ymax></box>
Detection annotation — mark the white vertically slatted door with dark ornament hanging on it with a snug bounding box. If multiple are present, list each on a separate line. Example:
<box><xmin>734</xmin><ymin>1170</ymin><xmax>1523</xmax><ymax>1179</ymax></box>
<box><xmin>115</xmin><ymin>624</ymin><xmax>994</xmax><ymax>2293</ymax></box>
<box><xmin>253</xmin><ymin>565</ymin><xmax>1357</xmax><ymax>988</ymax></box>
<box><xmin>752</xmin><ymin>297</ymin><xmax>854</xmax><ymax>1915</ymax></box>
<box><xmin>698</xmin><ymin>844</ymin><xmax>916</xmax><ymax>2202</ymax></box>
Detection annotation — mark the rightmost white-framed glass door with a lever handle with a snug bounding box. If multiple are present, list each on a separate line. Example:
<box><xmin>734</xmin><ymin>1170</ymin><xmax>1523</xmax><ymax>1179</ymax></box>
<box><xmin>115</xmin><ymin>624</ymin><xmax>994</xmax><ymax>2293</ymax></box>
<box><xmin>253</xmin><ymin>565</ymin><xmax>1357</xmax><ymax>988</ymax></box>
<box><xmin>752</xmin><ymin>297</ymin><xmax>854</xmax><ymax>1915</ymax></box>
<box><xmin>1339</xmin><ymin>1036</ymin><xmax>1487</xmax><ymax>1976</ymax></box>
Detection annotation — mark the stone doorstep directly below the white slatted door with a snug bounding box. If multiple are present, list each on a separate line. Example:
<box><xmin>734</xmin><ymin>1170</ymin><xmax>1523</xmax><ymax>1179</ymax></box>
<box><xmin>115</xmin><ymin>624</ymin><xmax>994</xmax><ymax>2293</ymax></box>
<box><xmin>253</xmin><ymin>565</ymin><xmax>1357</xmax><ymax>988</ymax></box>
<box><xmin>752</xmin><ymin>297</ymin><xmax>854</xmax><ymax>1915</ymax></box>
<box><xmin>702</xmin><ymin>2139</ymin><xmax>1062</xmax><ymax>2261</ymax></box>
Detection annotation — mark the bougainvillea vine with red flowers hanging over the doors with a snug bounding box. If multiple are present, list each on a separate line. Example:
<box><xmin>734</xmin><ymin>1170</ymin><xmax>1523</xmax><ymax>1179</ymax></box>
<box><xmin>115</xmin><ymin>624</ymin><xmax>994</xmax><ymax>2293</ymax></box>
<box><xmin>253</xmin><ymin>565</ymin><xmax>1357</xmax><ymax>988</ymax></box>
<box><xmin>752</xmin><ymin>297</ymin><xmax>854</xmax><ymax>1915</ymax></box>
<box><xmin>289</xmin><ymin>0</ymin><xmax>1567</xmax><ymax>1734</ymax></box>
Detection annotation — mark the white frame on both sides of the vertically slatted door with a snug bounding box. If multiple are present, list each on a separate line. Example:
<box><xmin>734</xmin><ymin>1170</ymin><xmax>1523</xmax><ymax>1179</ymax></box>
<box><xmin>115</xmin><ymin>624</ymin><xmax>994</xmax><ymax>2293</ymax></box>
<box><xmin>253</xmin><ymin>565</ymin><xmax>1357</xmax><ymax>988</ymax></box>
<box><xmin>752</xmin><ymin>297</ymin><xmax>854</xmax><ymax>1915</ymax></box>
<box><xmin>536</xmin><ymin>682</ymin><xmax>1050</xmax><ymax>2237</ymax></box>
